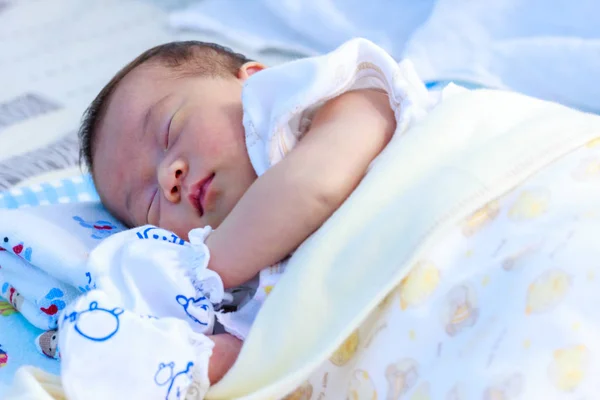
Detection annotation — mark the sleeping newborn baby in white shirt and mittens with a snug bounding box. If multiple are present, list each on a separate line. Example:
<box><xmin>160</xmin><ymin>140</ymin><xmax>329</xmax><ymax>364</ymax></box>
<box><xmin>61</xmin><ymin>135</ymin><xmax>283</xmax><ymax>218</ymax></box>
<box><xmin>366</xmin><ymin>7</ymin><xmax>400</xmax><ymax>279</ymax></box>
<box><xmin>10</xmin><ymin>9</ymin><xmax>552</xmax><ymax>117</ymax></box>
<box><xmin>60</xmin><ymin>39</ymin><xmax>435</xmax><ymax>399</ymax></box>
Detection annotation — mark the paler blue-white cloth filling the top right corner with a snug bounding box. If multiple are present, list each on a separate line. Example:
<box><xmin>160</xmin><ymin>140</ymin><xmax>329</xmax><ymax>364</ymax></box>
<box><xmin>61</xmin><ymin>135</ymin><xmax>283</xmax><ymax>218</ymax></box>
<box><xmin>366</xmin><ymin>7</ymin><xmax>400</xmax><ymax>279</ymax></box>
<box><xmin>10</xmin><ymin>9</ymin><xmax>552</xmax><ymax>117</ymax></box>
<box><xmin>403</xmin><ymin>0</ymin><xmax>600</xmax><ymax>113</ymax></box>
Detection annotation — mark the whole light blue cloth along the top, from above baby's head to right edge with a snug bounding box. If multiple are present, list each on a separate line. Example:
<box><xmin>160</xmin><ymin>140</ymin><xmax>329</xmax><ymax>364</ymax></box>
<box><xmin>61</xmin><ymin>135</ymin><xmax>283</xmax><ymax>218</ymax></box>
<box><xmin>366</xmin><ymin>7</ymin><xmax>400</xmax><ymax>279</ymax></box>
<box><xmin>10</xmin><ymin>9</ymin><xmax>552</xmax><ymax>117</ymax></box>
<box><xmin>171</xmin><ymin>0</ymin><xmax>600</xmax><ymax>112</ymax></box>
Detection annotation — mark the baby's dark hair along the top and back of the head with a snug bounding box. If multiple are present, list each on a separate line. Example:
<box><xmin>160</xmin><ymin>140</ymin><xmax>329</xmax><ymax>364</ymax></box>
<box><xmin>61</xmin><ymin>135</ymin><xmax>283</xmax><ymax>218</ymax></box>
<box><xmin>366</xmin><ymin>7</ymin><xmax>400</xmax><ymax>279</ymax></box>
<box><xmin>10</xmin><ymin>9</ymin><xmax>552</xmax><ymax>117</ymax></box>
<box><xmin>78</xmin><ymin>41</ymin><xmax>252</xmax><ymax>172</ymax></box>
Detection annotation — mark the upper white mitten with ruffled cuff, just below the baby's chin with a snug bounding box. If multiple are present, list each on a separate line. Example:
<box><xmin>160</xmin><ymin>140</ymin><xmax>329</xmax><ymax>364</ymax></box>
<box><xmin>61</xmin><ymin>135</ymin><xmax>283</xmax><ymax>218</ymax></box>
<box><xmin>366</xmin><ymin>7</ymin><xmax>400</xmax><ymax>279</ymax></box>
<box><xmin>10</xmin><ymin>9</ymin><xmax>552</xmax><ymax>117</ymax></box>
<box><xmin>88</xmin><ymin>225</ymin><xmax>224</xmax><ymax>333</ymax></box>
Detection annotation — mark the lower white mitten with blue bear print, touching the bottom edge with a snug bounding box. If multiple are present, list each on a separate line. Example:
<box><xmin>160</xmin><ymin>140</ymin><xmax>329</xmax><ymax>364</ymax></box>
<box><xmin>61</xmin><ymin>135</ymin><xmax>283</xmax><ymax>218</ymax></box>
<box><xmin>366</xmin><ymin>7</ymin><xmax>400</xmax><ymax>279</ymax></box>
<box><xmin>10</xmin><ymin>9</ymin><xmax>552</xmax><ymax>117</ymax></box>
<box><xmin>59</xmin><ymin>290</ymin><xmax>214</xmax><ymax>400</ymax></box>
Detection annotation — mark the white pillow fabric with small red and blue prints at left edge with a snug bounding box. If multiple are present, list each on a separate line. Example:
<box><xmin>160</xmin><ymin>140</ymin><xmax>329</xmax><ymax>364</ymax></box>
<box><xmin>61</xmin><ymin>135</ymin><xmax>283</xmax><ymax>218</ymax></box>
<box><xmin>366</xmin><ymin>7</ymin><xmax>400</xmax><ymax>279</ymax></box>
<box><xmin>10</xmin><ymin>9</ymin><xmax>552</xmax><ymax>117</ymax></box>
<box><xmin>0</xmin><ymin>202</ymin><xmax>124</xmax><ymax>330</ymax></box>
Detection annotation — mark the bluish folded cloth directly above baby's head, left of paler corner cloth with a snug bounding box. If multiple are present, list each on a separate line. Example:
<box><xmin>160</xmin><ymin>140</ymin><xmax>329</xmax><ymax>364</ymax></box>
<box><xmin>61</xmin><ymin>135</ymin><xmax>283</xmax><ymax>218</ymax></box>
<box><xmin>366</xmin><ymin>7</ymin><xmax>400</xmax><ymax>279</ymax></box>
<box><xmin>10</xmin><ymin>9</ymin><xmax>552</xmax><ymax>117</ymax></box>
<box><xmin>171</xmin><ymin>0</ymin><xmax>435</xmax><ymax>56</ymax></box>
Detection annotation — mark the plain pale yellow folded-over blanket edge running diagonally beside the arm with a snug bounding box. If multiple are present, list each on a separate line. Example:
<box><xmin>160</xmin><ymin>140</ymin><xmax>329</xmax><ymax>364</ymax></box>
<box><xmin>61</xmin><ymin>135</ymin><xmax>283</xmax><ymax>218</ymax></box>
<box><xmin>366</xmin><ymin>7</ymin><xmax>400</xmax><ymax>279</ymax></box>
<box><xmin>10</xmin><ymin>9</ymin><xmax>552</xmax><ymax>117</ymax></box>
<box><xmin>209</xmin><ymin>90</ymin><xmax>600</xmax><ymax>399</ymax></box>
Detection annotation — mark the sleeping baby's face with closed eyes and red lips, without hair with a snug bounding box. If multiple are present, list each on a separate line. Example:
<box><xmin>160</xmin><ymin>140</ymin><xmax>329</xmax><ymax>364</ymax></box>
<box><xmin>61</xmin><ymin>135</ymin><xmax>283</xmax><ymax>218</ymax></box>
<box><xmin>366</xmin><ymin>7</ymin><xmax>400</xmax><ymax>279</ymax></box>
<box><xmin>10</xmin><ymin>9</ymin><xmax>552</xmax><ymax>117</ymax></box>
<box><xmin>93</xmin><ymin>63</ymin><xmax>262</xmax><ymax>238</ymax></box>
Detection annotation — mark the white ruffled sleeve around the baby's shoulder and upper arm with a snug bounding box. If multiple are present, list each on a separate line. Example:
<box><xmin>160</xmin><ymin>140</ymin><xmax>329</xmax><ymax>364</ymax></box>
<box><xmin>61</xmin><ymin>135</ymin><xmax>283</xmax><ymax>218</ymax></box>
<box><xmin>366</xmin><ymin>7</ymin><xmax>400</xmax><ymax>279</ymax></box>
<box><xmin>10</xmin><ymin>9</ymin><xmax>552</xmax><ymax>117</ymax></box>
<box><xmin>242</xmin><ymin>39</ymin><xmax>439</xmax><ymax>175</ymax></box>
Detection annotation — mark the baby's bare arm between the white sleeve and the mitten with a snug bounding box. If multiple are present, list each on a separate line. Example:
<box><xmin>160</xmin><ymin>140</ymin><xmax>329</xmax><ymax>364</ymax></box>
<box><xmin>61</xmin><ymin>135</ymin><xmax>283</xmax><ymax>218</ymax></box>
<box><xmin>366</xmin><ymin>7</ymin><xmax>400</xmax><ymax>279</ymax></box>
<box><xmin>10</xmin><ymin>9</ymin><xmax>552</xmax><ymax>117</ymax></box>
<box><xmin>206</xmin><ymin>90</ymin><xmax>396</xmax><ymax>287</ymax></box>
